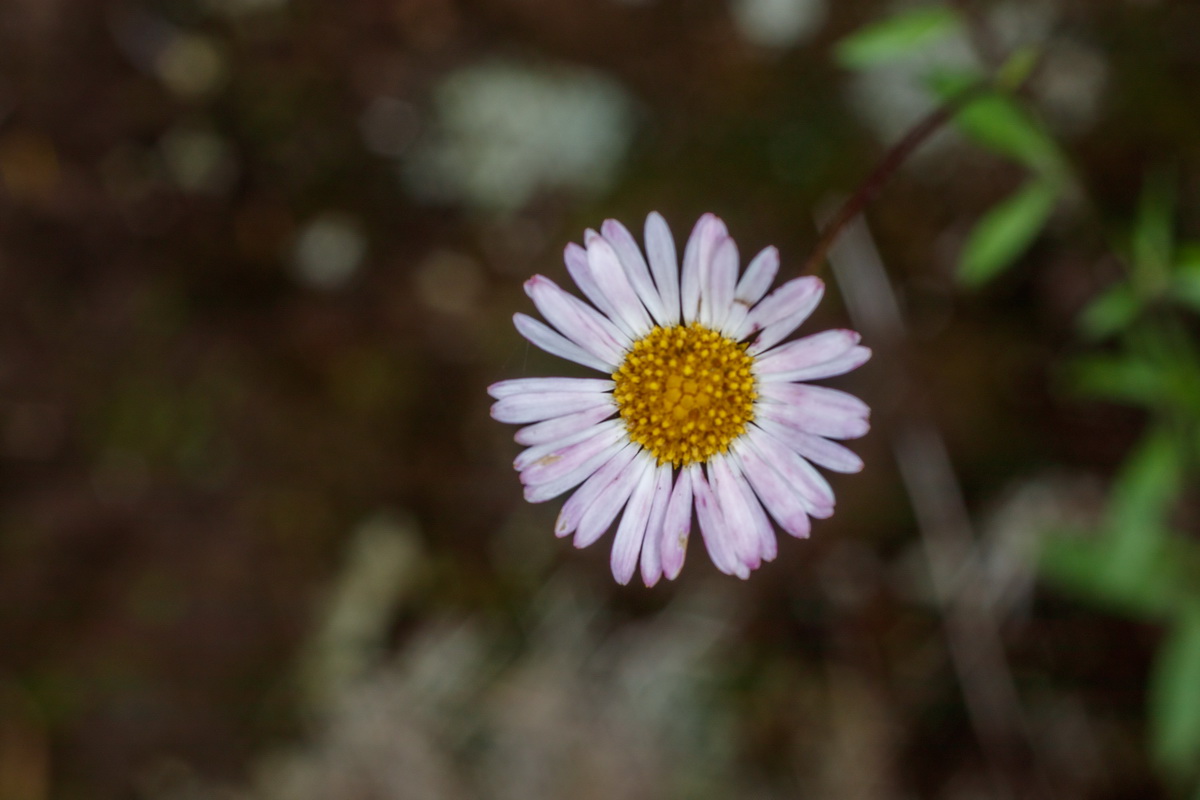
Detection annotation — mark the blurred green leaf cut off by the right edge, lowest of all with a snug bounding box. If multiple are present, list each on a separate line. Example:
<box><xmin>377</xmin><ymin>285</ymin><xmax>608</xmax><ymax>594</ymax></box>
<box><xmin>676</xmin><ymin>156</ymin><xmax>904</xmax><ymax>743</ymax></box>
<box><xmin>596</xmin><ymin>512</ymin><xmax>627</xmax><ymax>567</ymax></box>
<box><xmin>1148</xmin><ymin>601</ymin><xmax>1200</xmax><ymax>780</ymax></box>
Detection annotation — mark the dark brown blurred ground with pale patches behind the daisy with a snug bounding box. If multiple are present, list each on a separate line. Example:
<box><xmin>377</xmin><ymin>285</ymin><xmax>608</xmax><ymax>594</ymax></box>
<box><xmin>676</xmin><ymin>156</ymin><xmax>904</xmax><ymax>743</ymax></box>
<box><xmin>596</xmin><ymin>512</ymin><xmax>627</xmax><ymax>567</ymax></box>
<box><xmin>0</xmin><ymin>0</ymin><xmax>1200</xmax><ymax>800</ymax></box>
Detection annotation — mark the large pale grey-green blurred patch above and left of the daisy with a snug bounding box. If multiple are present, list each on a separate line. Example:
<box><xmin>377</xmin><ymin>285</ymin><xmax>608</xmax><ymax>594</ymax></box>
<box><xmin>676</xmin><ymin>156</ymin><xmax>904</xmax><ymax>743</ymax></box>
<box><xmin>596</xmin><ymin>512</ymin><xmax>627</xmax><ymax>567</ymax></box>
<box><xmin>402</xmin><ymin>62</ymin><xmax>632</xmax><ymax>211</ymax></box>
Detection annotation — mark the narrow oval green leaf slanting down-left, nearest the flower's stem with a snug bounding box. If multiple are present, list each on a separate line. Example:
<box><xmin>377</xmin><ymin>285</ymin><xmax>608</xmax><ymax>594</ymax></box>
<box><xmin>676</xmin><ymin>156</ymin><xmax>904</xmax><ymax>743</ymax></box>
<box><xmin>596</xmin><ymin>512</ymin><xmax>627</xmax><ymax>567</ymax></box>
<box><xmin>959</xmin><ymin>180</ymin><xmax>1058</xmax><ymax>285</ymax></box>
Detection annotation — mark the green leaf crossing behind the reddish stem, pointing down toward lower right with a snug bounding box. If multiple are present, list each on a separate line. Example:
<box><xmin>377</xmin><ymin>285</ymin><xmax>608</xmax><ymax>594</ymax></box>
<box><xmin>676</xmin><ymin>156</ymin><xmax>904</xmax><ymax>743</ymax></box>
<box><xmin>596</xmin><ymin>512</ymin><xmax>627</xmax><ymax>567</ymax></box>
<box><xmin>929</xmin><ymin>72</ymin><xmax>1069</xmax><ymax>176</ymax></box>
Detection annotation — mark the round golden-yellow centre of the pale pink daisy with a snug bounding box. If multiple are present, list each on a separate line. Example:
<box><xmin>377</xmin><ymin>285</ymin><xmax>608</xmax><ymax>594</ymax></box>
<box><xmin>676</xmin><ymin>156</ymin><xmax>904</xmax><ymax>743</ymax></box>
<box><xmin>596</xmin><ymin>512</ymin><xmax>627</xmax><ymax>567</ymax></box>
<box><xmin>612</xmin><ymin>323</ymin><xmax>758</xmax><ymax>467</ymax></box>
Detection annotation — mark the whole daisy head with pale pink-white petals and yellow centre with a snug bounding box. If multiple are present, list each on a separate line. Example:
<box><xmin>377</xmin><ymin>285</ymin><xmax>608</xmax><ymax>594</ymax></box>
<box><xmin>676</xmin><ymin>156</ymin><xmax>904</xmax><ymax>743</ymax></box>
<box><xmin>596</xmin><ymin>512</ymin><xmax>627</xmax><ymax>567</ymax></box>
<box><xmin>487</xmin><ymin>212</ymin><xmax>871</xmax><ymax>587</ymax></box>
